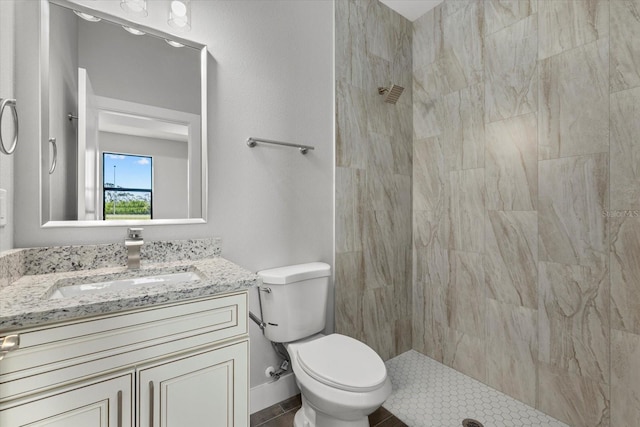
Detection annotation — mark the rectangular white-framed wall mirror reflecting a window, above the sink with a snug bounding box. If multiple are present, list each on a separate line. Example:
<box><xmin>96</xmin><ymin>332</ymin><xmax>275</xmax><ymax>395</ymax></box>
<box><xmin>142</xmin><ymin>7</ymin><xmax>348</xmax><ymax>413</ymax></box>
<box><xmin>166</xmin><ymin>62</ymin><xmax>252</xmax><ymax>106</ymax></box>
<box><xmin>40</xmin><ymin>0</ymin><xmax>207</xmax><ymax>227</ymax></box>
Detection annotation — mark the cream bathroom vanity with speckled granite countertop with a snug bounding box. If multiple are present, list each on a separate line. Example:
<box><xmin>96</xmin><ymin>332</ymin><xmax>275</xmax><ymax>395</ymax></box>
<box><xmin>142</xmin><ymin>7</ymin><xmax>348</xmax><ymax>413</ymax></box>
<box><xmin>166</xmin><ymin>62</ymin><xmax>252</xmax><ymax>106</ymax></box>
<box><xmin>0</xmin><ymin>241</ymin><xmax>257</xmax><ymax>427</ymax></box>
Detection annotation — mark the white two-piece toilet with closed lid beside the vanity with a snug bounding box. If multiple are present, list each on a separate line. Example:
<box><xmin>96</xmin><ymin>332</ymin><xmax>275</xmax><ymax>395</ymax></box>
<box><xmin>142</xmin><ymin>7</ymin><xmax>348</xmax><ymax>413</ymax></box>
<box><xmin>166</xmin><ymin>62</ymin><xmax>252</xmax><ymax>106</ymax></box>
<box><xmin>258</xmin><ymin>262</ymin><xmax>391</xmax><ymax>427</ymax></box>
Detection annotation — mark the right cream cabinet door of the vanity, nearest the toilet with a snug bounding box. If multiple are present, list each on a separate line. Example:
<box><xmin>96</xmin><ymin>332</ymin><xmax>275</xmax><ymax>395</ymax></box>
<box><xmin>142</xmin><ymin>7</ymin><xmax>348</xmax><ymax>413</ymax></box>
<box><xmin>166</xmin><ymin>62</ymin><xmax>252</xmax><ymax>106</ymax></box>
<box><xmin>138</xmin><ymin>341</ymin><xmax>249</xmax><ymax>427</ymax></box>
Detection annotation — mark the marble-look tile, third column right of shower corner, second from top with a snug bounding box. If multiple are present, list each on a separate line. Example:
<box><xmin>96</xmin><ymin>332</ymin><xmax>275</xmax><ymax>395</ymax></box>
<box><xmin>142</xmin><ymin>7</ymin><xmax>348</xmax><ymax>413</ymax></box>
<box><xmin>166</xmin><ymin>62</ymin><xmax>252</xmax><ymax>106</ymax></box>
<box><xmin>484</xmin><ymin>13</ymin><xmax>538</xmax><ymax>122</ymax></box>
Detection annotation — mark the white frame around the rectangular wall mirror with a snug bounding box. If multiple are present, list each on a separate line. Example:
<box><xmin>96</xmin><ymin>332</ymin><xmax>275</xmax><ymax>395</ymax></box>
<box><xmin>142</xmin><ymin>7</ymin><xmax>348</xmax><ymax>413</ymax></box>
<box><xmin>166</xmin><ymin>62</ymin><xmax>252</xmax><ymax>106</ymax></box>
<box><xmin>37</xmin><ymin>0</ymin><xmax>208</xmax><ymax>228</ymax></box>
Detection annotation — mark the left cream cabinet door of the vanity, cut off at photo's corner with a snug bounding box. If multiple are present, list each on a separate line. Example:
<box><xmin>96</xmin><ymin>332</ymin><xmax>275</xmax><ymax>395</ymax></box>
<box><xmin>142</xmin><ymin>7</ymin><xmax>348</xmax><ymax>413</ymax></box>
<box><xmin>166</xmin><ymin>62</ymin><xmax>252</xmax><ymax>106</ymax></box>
<box><xmin>0</xmin><ymin>373</ymin><xmax>133</xmax><ymax>427</ymax></box>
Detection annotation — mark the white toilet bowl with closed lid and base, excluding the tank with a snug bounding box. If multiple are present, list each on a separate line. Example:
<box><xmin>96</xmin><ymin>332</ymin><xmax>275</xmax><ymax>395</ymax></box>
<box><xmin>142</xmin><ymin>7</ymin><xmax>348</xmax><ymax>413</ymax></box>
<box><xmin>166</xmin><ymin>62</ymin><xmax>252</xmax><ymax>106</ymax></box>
<box><xmin>285</xmin><ymin>334</ymin><xmax>391</xmax><ymax>427</ymax></box>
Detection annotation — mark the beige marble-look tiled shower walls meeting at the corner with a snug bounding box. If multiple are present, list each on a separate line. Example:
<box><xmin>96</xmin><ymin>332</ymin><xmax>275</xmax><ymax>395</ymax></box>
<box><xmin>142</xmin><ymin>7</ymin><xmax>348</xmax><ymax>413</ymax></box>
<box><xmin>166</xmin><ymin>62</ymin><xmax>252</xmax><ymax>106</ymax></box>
<box><xmin>336</xmin><ymin>0</ymin><xmax>640</xmax><ymax>427</ymax></box>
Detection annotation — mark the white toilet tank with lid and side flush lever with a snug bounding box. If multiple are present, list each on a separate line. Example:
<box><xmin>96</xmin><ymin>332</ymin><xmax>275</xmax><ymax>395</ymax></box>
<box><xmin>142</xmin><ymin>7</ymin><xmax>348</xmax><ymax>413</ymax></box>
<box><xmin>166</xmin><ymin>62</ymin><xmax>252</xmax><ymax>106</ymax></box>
<box><xmin>258</xmin><ymin>262</ymin><xmax>331</xmax><ymax>342</ymax></box>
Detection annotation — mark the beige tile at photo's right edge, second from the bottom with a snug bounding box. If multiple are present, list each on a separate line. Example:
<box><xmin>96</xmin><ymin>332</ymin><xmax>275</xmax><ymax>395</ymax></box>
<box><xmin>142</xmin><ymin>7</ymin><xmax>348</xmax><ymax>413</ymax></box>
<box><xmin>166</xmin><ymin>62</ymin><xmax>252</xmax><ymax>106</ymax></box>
<box><xmin>610</xmin><ymin>218</ymin><xmax>640</xmax><ymax>334</ymax></box>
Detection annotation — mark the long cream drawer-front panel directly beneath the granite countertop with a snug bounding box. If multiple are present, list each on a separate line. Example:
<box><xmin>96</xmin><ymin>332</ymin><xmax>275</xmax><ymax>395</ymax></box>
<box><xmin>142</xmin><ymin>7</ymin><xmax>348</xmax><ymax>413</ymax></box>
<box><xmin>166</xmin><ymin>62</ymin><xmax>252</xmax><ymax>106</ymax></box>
<box><xmin>0</xmin><ymin>292</ymin><xmax>247</xmax><ymax>402</ymax></box>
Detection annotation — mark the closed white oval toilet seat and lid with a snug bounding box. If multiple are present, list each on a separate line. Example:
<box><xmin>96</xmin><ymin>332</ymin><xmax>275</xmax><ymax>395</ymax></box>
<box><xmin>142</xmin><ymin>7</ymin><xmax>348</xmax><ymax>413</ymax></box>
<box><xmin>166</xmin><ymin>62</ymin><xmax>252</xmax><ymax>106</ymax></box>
<box><xmin>297</xmin><ymin>334</ymin><xmax>387</xmax><ymax>392</ymax></box>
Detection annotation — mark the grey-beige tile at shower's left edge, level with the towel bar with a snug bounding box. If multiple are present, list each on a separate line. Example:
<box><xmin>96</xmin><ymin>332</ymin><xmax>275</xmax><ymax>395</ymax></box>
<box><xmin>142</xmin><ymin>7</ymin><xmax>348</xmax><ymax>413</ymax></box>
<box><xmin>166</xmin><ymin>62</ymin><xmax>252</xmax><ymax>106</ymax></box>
<box><xmin>336</xmin><ymin>81</ymin><xmax>369</xmax><ymax>169</ymax></box>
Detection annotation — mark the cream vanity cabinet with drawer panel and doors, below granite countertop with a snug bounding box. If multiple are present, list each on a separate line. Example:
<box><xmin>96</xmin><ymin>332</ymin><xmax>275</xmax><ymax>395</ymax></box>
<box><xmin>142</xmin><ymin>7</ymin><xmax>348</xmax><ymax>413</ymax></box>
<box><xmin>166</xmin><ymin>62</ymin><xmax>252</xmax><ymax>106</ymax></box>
<box><xmin>0</xmin><ymin>291</ymin><xmax>249</xmax><ymax>427</ymax></box>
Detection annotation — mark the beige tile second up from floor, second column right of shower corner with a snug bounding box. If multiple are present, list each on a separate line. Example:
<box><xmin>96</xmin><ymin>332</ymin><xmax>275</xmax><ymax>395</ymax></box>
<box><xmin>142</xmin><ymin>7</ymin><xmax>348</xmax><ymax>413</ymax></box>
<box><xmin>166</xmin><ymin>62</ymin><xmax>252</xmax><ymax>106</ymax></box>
<box><xmin>446</xmin><ymin>251</ymin><xmax>486</xmax><ymax>338</ymax></box>
